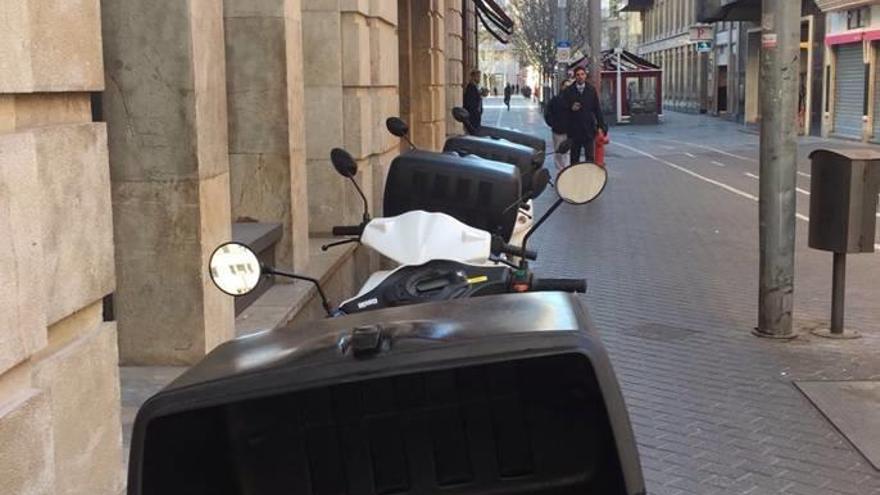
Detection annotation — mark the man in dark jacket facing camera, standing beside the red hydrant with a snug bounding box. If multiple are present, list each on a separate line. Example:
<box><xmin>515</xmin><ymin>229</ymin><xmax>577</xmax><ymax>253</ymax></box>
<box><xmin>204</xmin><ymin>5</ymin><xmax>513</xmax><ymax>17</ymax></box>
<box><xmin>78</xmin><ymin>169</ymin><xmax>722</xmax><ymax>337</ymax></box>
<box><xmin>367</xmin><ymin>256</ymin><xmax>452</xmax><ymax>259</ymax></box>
<box><xmin>562</xmin><ymin>67</ymin><xmax>608</xmax><ymax>163</ymax></box>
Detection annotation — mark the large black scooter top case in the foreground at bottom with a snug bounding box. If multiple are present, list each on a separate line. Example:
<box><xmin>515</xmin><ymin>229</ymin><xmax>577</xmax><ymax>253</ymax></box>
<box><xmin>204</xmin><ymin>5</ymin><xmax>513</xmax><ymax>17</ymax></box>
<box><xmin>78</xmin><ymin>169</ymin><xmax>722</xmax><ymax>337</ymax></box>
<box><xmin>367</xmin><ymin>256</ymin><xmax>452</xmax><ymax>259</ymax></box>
<box><xmin>128</xmin><ymin>292</ymin><xmax>645</xmax><ymax>495</ymax></box>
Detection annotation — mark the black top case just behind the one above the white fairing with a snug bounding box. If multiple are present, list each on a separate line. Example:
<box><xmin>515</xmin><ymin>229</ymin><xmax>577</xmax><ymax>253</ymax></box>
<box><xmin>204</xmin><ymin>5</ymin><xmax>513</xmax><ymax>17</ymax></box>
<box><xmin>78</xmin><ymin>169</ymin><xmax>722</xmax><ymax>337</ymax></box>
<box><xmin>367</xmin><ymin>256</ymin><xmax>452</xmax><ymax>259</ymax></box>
<box><xmin>443</xmin><ymin>136</ymin><xmax>544</xmax><ymax>196</ymax></box>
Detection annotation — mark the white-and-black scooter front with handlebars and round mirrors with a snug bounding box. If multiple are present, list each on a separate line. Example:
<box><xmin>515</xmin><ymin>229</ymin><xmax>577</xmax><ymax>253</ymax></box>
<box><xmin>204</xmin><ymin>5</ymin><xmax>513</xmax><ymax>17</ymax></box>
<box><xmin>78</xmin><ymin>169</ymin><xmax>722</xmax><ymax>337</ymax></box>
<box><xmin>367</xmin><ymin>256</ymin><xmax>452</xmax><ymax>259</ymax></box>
<box><xmin>210</xmin><ymin>148</ymin><xmax>607</xmax><ymax>316</ymax></box>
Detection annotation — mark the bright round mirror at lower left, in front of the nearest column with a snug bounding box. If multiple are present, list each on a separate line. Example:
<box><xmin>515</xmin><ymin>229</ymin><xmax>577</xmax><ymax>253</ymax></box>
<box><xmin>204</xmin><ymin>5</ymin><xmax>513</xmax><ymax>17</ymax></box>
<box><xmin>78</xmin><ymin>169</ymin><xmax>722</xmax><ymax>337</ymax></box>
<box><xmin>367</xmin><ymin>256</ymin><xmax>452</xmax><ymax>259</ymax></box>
<box><xmin>209</xmin><ymin>242</ymin><xmax>262</xmax><ymax>296</ymax></box>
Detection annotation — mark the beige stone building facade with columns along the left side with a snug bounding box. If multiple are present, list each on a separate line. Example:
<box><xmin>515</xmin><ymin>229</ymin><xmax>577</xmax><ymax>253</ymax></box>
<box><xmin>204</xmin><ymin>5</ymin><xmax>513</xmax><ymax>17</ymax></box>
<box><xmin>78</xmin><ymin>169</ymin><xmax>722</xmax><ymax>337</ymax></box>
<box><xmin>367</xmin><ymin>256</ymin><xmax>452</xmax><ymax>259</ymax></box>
<box><xmin>0</xmin><ymin>0</ymin><xmax>477</xmax><ymax>495</ymax></box>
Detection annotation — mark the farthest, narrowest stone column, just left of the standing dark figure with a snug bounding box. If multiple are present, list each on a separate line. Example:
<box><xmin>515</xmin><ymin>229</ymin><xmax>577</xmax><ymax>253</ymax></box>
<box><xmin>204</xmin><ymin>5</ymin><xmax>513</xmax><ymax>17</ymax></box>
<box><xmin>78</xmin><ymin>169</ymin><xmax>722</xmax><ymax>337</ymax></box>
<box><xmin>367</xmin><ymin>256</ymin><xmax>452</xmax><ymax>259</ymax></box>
<box><xmin>443</xmin><ymin>0</ymin><xmax>467</xmax><ymax>136</ymax></box>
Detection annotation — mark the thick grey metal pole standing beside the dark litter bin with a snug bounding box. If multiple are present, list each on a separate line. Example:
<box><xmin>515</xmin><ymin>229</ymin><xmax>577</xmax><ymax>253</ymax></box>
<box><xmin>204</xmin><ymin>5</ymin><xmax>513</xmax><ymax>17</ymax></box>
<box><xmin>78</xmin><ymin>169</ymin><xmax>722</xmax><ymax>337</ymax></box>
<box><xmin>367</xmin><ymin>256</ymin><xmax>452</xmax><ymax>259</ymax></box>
<box><xmin>755</xmin><ymin>0</ymin><xmax>801</xmax><ymax>338</ymax></box>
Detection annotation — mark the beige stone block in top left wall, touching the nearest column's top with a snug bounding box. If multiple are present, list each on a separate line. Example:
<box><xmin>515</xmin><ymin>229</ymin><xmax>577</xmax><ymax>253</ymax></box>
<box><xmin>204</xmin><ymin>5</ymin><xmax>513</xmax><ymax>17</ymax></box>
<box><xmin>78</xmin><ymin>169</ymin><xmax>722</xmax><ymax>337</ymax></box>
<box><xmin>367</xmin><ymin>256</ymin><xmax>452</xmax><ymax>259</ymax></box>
<box><xmin>27</xmin><ymin>0</ymin><xmax>104</xmax><ymax>92</ymax></box>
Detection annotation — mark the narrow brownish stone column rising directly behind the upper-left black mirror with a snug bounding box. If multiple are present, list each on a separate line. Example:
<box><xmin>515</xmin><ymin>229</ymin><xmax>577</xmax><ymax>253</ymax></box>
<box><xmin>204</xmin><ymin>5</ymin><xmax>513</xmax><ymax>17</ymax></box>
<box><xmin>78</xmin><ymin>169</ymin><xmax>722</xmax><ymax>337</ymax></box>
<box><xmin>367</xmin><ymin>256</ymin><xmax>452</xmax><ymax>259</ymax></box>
<box><xmin>410</xmin><ymin>0</ymin><xmax>446</xmax><ymax>150</ymax></box>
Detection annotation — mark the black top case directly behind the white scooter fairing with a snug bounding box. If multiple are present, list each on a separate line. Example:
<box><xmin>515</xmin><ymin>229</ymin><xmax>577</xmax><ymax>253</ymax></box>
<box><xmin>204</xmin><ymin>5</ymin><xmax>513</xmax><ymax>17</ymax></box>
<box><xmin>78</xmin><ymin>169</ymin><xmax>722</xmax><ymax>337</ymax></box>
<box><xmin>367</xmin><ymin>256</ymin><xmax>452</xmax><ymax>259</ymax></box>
<box><xmin>382</xmin><ymin>150</ymin><xmax>521</xmax><ymax>241</ymax></box>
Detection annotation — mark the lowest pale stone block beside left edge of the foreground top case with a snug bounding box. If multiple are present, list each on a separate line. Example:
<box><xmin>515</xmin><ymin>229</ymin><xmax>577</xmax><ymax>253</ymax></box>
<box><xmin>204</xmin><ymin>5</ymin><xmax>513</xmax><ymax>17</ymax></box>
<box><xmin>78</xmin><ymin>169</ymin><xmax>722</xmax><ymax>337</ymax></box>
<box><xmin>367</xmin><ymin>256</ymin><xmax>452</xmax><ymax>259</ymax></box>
<box><xmin>34</xmin><ymin>322</ymin><xmax>125</xmax><ymax>495</ymax></box>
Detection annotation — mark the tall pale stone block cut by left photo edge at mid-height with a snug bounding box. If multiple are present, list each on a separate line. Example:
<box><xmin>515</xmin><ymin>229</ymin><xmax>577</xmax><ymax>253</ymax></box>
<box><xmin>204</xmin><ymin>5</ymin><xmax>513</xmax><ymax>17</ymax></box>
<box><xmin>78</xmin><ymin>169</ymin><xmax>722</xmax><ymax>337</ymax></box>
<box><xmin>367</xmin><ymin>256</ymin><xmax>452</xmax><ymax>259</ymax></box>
<box><xmin>0</xmin><ymin>133</ymin><xmax>47</xmax><ymax>376</ymax></box>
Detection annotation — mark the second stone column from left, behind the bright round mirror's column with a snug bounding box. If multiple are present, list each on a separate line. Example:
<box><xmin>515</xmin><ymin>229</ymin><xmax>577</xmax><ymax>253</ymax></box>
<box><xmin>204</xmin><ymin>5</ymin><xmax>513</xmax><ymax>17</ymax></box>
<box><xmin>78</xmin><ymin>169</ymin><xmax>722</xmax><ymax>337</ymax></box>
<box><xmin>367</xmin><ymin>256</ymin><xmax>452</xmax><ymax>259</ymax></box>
<box><xmin>223</xmin><ymin>0</ymin><xmax>309</xmax><ymax>270</ymax></box>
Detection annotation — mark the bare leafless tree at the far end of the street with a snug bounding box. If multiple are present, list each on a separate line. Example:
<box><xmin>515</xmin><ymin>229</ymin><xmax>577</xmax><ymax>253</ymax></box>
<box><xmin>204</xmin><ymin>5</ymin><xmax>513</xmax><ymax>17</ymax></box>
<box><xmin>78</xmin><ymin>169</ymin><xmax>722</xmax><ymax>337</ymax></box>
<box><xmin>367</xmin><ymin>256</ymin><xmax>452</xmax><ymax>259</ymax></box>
<box><xmin>510</xmin><ymin>0</ymin><xmax>598</xmax><ymax>80</ymax></box>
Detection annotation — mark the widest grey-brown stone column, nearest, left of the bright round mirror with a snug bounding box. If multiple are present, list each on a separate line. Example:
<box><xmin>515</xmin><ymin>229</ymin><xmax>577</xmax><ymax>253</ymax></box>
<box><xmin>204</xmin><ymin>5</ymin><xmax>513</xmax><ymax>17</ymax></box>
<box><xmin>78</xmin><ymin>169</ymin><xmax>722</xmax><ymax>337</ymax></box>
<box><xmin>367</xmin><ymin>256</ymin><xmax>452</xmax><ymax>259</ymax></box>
<box><xmin>102</xmin><ymin>0</ymin><xmax>233</xmax><ymax>365</ymax></box>
